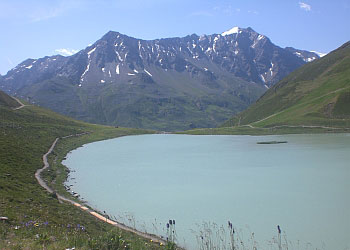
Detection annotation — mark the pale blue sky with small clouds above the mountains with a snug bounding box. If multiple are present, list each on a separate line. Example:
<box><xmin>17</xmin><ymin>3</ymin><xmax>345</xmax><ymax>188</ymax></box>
<box><xmin>0</xmin><ymin>0</ymin><xmax>350</xmax><ymax>75</ymax></box>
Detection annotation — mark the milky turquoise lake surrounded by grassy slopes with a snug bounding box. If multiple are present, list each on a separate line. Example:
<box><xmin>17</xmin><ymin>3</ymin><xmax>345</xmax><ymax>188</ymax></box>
<box><xmin>63</xmin><ymin>134</ymin><xmax>350</xmax><ymax>250</ymax></box>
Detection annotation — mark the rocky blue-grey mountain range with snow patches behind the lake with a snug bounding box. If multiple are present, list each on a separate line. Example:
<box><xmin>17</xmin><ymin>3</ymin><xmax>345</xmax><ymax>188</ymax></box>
<box><xmin>0</xmin><ymin>27</ymin><xmax>319</xmax><ymax>130</ymax></box>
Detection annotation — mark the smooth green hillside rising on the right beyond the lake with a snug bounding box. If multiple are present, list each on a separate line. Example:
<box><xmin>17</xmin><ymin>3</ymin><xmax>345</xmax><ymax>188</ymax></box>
<box><xmin>223</xmin><ymin>42</ymin><xmax>350</xmax><ymax>128</ymax></box>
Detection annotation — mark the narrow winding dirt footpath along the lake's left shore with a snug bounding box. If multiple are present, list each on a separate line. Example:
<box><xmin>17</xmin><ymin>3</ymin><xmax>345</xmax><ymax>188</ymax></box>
<box><xmin>35</xmin><ymin>133</ymin><xmax>166</xmax><ymax>245</ymax></box>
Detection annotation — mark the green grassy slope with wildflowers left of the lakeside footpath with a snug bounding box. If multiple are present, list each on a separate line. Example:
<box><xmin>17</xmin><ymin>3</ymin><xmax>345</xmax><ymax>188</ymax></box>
<box><xmin>0</xmin><ymin>96</ymin><xmax>171</xmax><ymax>249</ymax></box>
